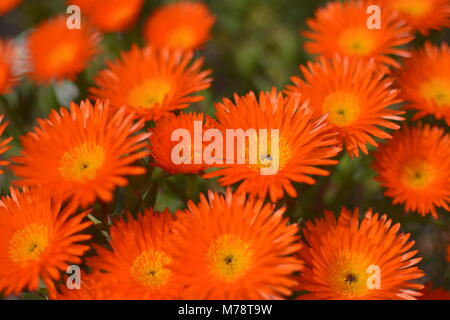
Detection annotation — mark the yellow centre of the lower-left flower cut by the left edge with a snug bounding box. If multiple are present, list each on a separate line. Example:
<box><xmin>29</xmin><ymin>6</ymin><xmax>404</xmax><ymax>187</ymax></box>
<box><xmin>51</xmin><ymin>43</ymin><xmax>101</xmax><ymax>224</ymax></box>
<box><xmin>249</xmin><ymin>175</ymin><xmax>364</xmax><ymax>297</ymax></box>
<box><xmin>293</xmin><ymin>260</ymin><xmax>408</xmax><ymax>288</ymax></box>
<box><xmin>9</xmin><ymin>223</ymin><xmax>48</xmax><ymax>262</ymax></box>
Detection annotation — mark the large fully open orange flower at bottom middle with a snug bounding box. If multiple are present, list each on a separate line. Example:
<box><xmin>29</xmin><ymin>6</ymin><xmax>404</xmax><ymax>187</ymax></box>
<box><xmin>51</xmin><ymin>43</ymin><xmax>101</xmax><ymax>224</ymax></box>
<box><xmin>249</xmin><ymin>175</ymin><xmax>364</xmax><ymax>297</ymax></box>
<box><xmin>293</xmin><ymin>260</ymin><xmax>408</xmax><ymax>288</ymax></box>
<box><xmin>172</xmin><ymin>189</ymin><xmax>302</xmax><ymax>300</ymax></box>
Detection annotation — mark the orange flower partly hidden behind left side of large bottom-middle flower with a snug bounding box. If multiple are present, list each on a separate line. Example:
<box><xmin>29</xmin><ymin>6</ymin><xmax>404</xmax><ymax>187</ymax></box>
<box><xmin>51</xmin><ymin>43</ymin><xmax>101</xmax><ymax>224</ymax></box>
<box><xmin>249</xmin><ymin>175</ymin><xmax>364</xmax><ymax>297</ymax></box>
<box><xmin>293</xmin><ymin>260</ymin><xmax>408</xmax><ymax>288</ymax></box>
<box><xmin>89</xmin><ymin>209</ymin><xmax>182</xmax><ymax>300</ymax></box>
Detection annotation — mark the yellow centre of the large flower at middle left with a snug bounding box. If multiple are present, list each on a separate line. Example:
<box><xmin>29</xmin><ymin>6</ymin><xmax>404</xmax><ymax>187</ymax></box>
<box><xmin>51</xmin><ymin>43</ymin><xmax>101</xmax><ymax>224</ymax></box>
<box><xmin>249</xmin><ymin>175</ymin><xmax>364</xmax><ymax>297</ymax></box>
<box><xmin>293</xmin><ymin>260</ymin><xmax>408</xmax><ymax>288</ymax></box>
<box><xmin>59</xmin><ymin>142</ymin><xmax>105</xmax><ymax>181</ymax></box>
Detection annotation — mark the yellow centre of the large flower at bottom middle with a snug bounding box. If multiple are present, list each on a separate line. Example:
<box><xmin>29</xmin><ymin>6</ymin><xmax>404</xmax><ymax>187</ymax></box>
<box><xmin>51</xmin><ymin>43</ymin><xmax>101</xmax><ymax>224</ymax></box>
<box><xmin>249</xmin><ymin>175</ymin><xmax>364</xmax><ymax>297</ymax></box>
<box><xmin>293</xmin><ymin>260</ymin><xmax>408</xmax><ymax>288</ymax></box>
<box><xmin>207</xmin><ymin>235</ymin><xmax>253</xmax><ymax>281</ymax></box>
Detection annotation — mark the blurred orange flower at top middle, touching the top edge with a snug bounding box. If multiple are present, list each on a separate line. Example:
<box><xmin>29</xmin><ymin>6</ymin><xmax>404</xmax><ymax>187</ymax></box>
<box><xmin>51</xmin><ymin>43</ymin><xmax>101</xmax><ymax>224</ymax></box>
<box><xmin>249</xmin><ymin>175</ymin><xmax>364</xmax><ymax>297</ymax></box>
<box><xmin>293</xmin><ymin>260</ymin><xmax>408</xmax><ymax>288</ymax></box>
<box><xmin>144</xmin><ymin>1</ymin><xmax>215</xmax><ymax>50</ymax></box>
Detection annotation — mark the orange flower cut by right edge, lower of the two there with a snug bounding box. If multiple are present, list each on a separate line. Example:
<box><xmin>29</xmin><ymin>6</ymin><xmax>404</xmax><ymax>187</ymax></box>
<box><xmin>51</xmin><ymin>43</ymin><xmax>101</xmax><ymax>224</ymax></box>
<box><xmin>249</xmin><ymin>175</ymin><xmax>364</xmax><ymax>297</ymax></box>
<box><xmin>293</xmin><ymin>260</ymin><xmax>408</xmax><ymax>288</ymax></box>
<box><xmin>373</xmin><ymin>125</ymin><xmax>450</xmax><ymax>218</ymax></box>
